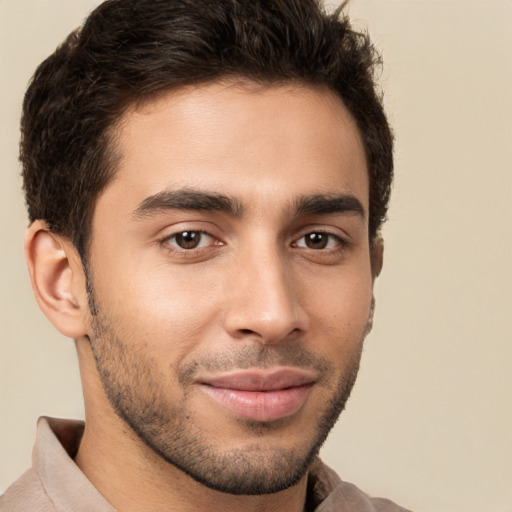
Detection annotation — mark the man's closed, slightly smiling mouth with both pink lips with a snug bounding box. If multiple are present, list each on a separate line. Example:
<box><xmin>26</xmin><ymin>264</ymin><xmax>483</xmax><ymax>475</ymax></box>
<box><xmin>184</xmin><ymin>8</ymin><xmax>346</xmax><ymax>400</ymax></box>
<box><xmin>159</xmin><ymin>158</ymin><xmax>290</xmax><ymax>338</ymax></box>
<box><xmin>198</xmin><ymin>368</ymin><xmax>317</xmax><ymax>422</ymax></box>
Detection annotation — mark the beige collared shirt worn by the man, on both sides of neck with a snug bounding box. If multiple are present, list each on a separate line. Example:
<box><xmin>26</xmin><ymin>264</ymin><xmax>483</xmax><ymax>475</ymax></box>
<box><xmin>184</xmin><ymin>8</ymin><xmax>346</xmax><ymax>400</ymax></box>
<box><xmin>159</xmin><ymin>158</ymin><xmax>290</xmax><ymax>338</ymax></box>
<box><xmin>0</xmin><ymin>417</ymin><xmax>410</xmax><ymax>512</ymax></box>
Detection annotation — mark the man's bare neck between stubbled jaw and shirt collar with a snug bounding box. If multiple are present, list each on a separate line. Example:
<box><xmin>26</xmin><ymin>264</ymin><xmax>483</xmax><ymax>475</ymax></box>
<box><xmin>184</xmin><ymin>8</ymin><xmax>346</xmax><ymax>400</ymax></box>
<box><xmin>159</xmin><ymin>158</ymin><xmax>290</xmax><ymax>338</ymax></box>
<box><xmin>75</xmin><ymin>340</ymin><xmax>307</xmax><ymax>512</ymax></box>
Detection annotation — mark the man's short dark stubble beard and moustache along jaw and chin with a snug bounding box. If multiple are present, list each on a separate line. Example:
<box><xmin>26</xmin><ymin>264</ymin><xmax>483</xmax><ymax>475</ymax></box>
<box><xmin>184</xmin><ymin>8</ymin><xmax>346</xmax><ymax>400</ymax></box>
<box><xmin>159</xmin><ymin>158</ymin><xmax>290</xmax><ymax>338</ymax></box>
<box><xmin>89</xmin><ymin>288</ymin><xmax>362</xmax><ymax>495</ymax></box>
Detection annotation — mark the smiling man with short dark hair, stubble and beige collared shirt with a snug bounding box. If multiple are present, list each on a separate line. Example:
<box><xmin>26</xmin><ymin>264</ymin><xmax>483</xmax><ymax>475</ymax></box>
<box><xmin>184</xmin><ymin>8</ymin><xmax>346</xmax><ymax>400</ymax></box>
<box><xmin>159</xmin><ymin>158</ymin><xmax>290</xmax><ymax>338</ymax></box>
<box><xmin>0</xmin><ymin>0</ymin><xmax>404</xmax><ymax>512</ymax></box>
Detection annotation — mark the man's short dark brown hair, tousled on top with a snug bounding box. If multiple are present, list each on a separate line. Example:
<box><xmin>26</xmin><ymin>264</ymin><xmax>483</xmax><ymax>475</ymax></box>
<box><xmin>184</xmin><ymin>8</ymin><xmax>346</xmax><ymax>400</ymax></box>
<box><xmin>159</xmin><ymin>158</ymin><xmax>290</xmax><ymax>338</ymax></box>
<box><xmin>20</xmin><ymin>0</ymin><xmax>393</xmax><ymax>258</ymax></box>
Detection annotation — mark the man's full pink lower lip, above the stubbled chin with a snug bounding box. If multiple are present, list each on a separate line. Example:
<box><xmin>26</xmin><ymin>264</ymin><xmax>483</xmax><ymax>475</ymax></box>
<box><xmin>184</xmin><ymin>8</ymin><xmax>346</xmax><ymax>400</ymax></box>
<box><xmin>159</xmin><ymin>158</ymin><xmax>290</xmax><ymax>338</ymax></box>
<box><xmin>202</xmin><ymin>385</ymin><xmax>311</xmax><ymax>421</ymax></box>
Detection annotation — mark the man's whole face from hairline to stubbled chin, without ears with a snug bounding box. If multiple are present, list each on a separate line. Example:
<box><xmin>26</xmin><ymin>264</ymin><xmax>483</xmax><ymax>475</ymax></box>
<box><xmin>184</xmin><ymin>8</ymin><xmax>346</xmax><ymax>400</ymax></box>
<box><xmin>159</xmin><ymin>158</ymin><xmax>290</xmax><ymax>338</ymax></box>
<box><xmin>88</xmin><ymin>84</ymin><xmax>372</xmax><ymax>494</ymax></box>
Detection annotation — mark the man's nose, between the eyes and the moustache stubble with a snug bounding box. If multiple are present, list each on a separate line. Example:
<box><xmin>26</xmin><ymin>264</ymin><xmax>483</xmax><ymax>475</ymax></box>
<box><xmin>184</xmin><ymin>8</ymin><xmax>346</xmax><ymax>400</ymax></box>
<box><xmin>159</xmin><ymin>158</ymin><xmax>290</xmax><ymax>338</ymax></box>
<box><xmin>224</xmin><ymin>244</ymin><xmax>308</xmax><ymax>344</ymax></box>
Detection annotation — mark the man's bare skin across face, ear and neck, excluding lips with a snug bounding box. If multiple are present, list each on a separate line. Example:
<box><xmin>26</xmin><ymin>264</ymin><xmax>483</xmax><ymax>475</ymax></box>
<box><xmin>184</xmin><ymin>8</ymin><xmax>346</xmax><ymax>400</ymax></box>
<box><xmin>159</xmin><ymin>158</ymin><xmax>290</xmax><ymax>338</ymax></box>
<box><xmin>26</xmin><ymin>83</ymin><xmax>382</xmax><ymax>512</ymax></box>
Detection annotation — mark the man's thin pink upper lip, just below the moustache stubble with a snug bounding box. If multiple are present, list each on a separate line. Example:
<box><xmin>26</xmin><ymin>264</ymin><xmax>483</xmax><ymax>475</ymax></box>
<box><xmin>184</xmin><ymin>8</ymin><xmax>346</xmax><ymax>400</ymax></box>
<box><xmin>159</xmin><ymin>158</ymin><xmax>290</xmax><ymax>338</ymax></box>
<box><xmin>198</xmin><ymin>367</ymin><xmax>317</xmax><ymax>391</ymax></box>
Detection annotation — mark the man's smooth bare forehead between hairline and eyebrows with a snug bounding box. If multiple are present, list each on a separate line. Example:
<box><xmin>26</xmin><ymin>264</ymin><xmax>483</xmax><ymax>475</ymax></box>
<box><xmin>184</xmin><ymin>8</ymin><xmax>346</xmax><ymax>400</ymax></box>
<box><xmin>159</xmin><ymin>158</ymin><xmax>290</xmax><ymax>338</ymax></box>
<box><xmin>97</xmin><ymin>83</ymin><xmax>368</xmax><ymax>220</ymax></box>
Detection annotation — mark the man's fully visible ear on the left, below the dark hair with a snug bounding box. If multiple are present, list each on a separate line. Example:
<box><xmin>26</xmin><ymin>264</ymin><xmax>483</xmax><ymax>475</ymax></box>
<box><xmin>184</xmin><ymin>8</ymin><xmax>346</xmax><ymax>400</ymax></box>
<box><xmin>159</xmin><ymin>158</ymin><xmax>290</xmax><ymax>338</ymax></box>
<box><xmin>25</xmin><ymin>220</ymin><xmax>88</xmax><ymax>339</ymax></box>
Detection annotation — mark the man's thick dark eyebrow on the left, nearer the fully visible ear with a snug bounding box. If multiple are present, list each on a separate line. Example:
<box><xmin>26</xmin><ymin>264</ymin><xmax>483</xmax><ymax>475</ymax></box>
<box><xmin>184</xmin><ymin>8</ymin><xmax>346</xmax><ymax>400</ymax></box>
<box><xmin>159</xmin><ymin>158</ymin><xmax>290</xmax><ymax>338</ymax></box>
<box><xmin>133</xmin><ymin>188</ymin><xmax>242</xmax><ymax>220</ymax></box>
